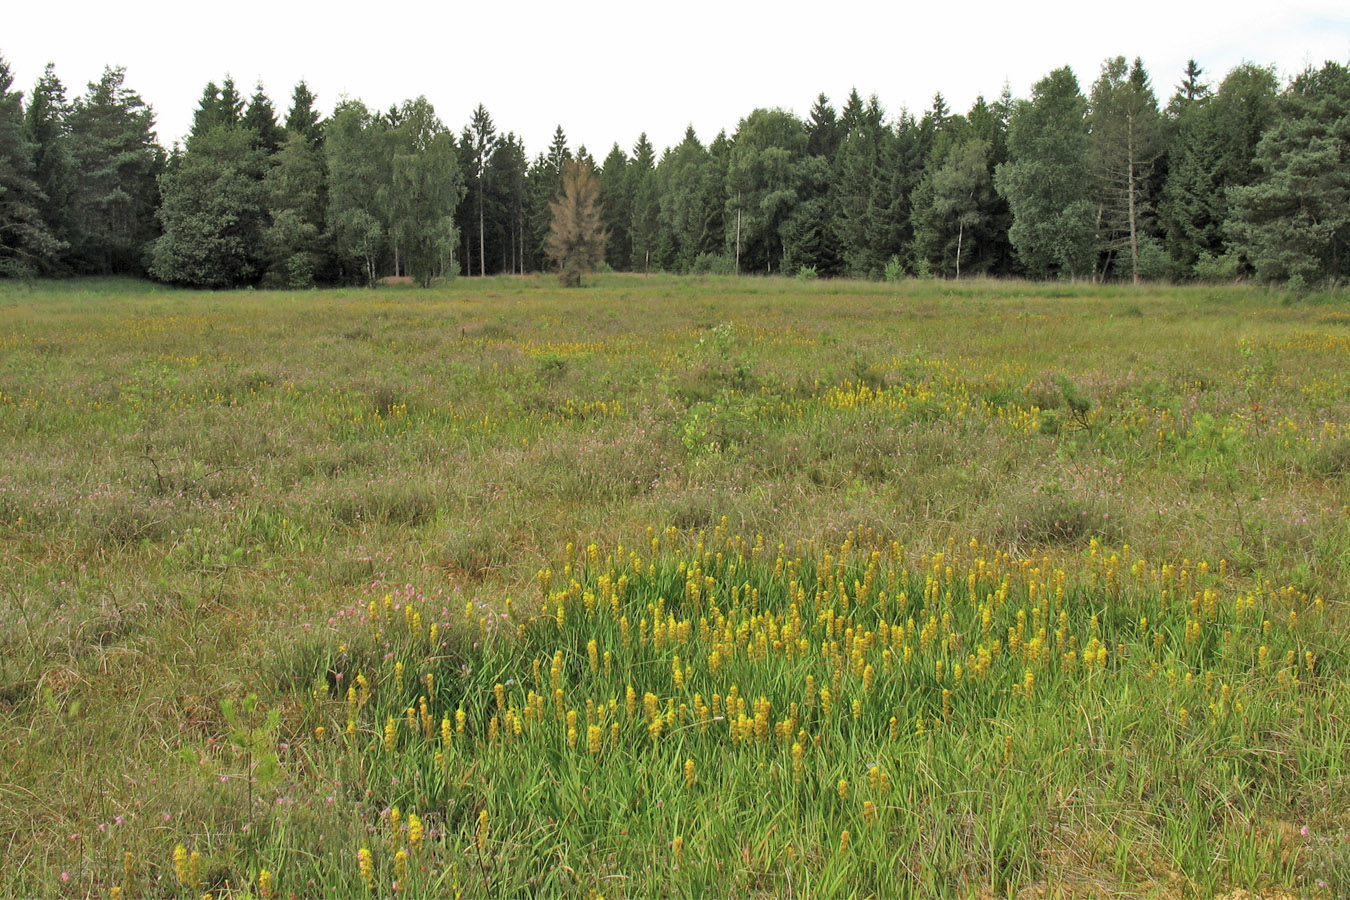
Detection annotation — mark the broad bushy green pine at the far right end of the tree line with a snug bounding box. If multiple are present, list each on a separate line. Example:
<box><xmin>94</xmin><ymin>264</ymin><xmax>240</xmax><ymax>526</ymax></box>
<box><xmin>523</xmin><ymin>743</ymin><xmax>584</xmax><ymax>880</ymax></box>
<box><xmin>1229</xmin><ymin>62</ymin><xmax>1350</xmax><ymax>285</ymax></box>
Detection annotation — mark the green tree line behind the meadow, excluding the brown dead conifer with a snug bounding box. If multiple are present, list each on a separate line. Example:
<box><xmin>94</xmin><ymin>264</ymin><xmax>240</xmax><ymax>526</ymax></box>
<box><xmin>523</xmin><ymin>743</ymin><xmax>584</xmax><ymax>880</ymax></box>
<box><xmin>0</xmin><ymin>50</ymin><xmax>1350</xmax><ymax>287</ymax></box>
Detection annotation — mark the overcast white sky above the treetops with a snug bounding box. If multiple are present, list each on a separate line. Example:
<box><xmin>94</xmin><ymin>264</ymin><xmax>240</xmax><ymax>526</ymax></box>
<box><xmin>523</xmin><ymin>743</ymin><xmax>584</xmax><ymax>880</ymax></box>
<box><xmin>0</xmin><ymin>0</ymin><xmax>1350</xmax><ymax>159</ymax></box>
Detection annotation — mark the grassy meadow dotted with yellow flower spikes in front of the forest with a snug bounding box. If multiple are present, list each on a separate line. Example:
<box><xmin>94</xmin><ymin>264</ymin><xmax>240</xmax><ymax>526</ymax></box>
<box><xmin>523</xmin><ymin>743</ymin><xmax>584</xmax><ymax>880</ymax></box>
<box><xmin>0</xmin><ymin>275</ymin><xmax>1350</xmax><ymax>900</ymax></box>
